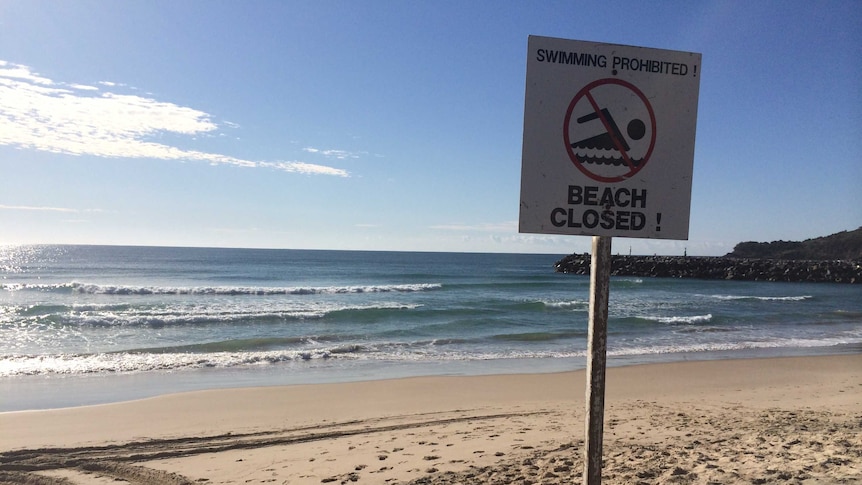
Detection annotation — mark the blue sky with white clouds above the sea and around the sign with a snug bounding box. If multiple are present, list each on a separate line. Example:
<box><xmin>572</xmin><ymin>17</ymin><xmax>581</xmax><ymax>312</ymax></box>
<box><xmin>0</xmin><ymin>0</ymin><xmax>862</xmax><ymax>255</ymax></box>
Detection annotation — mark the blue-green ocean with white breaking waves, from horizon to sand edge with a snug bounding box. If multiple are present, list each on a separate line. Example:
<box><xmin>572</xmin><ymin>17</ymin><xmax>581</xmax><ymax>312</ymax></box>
<box><xmin>0</xmin><ymin>246</ymin><xmax>862</xmax><ymax>411</ymax></box>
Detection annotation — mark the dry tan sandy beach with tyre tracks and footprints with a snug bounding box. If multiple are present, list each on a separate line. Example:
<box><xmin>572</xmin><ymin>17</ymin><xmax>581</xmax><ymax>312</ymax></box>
<box><xmin>0</xmin><ymin>355</ymin><xmax>862</xmax><ymax>485</ymax></box>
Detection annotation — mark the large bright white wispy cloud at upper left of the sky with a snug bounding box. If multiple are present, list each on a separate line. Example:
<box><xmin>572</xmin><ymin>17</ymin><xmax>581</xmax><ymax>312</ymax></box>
<box><xmin>0</xmin><ymin>60</ymin><xmax>349</xmax><ymax>177</ymax></box>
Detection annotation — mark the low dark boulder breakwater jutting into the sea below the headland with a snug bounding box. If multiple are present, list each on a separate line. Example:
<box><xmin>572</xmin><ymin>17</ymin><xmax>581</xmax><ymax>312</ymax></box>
<box><xmin>554</xmin><ymin>254</ymin><xmax>862</xmax><ymax>284</ymax></box>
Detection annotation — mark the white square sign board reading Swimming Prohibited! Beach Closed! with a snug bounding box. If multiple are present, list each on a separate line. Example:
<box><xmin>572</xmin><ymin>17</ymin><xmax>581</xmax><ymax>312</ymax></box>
<box><xmin>519</xmin><ymin>36</ymin><xmax>701</xmax><ymax>239</ymax></box>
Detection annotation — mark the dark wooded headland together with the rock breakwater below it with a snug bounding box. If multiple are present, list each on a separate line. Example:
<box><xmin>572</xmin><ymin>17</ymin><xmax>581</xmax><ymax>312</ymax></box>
<box><xmin>554</xmin><ymin>227</ymin><xmax>862</xmax><ymax>284</ymax></box>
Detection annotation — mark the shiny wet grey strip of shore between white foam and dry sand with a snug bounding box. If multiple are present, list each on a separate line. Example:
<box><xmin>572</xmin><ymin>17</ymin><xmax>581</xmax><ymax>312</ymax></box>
<box><xmin>0</xmin><ymin>344</ymin><xmax>862</xmax><ymax>414</ymax></box>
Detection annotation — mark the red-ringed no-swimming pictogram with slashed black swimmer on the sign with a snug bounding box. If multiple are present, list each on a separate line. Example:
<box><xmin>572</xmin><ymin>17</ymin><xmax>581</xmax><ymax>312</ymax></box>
<box><xmin>563</xmin><ymin>78</ymin><xmax>656</xmax><ymax>183</ymax></box>
